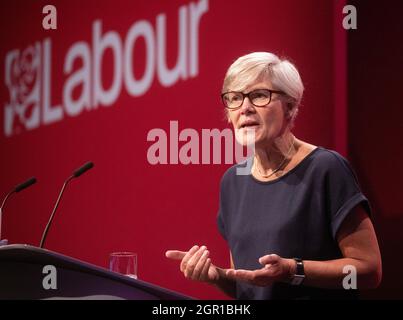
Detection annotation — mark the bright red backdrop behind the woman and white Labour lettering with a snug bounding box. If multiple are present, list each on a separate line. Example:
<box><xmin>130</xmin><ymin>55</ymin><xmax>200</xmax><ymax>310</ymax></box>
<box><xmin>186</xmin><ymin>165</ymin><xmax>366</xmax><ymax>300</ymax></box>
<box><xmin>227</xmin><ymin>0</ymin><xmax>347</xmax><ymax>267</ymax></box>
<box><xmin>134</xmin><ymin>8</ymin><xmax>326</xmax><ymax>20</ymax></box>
<box><xmin>0</xmin><ymin>0</ymin><xmax>401</xmax><ymax>299</ymax></box>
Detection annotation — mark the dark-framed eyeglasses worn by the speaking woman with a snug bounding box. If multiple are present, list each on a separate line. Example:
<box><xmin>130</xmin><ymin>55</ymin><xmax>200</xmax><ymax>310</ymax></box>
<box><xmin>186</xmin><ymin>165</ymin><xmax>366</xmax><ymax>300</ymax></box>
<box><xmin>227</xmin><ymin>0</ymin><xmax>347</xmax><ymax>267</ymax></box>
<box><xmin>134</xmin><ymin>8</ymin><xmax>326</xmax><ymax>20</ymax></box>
<box><xmin>221</xmin><ymin>89</ymin><xmax>285</xmax><ymax>110</ymax></box>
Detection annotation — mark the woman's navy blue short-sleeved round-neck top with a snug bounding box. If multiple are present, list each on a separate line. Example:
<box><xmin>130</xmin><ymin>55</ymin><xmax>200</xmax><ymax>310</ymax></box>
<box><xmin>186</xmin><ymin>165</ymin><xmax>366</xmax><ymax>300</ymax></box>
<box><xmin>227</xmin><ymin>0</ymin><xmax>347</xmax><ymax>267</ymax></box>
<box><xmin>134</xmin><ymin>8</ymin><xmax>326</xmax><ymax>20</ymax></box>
<box><xmin>217</xmin><ymin>147</ymin><xmax>370</xmax><ymax>299</ymax></box>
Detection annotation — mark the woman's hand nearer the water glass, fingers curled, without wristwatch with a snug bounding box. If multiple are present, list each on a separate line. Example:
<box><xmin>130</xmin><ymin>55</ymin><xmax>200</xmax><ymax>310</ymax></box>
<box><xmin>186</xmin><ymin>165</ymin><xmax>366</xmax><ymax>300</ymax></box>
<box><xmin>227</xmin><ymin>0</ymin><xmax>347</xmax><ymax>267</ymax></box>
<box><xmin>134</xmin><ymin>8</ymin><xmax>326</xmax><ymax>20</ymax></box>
<box><xmin>165</xmin><ymin>246</ymin><xmax>220</xmax><ymax>284</ymax></box>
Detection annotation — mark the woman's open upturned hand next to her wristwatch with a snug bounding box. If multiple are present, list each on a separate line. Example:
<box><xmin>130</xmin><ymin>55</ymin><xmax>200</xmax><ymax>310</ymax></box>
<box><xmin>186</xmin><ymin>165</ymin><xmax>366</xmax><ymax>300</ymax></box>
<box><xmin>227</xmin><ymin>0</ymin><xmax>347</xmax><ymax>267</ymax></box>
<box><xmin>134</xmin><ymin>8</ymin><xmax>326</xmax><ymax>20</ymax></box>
<box><xmin>226</xmin><ymin>254</ymin><xmax>295</xmax><ymax>287</ymax></box>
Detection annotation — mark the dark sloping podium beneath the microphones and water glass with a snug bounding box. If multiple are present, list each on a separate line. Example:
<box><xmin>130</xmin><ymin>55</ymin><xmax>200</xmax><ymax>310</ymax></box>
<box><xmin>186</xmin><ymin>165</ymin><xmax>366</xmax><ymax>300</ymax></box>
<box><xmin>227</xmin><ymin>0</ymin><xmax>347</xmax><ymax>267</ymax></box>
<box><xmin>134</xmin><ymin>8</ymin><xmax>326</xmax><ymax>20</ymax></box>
<box><xmin>0</xmin><ymin>244</ymin><xmax>191</xmax><ymax>300</ymax></box>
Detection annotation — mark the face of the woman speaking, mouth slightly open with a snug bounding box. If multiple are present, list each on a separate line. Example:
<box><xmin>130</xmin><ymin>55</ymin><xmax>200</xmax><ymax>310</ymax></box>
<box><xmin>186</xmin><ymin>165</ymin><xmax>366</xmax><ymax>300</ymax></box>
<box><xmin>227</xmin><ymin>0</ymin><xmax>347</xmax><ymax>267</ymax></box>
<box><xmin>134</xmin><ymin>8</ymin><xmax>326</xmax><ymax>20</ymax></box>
<box><xmin>228</xmin><ymin>80</ymin><xmax>289</xmax><ymax>147</ymax></box>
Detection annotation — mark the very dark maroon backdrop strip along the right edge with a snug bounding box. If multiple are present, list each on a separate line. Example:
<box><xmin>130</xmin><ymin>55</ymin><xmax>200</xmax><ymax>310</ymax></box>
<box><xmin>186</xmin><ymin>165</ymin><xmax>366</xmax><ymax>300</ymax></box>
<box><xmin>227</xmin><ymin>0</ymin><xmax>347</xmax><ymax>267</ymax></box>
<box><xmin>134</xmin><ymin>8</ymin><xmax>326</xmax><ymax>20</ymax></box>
<box><xmin>348</xmin><ymin>0</ymin><xmax>403</xmax><ymax>299</ymax></box>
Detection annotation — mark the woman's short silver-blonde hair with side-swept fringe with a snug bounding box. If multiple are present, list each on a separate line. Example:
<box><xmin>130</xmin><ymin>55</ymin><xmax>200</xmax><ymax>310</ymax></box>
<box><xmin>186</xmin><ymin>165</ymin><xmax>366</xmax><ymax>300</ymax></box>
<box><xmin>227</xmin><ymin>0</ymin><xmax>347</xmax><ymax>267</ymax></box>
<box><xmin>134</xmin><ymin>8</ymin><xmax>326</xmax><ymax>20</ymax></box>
<box><xmin>222</xmin><ymin>52</ymin><xmax>304</xmax><ymax>122</ymax></box>
